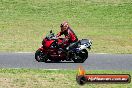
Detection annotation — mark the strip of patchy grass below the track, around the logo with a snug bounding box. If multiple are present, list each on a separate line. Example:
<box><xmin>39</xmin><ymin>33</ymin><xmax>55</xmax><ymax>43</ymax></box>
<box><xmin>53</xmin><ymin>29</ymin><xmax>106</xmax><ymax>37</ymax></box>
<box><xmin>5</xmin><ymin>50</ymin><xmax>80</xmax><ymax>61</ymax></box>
<box><xmin>0</xmin><ymin>69</ymin><xmax>132</xmax><ymax>88</ymax></box>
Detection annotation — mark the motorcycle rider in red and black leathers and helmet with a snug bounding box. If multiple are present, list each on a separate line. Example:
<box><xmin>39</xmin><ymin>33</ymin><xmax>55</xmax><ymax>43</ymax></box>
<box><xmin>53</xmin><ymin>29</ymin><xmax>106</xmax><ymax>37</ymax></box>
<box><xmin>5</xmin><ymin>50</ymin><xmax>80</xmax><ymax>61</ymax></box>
<box><xmin>57</xmin><ymin>21</ymin><xmax>78</xmax><ymax>50</ymax></box>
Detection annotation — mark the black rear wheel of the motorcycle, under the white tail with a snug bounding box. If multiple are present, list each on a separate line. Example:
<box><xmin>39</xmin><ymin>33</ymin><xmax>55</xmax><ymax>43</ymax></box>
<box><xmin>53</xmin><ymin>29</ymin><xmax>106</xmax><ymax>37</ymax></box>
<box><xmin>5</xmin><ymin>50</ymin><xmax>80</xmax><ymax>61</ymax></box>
<box><xmin>73</xmin><ymin>49</ymin><xmax>88</xmax><ymax>63</ymax></box>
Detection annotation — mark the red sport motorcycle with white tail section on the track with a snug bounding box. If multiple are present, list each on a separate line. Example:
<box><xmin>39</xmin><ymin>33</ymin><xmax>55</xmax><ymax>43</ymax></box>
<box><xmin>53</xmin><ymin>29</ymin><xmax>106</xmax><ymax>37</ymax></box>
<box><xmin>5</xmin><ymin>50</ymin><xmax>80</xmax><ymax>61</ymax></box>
<box><xmin>35</xmin><ymin>30</ymin><xmax>92</xmax><ymax>63</ymax></box>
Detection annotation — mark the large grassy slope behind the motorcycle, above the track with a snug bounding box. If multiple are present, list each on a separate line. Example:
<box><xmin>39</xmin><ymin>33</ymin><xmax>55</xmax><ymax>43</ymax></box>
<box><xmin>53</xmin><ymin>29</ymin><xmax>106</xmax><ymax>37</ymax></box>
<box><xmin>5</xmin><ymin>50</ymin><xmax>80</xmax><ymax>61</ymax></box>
<box><xmin>0</xmin><ymin>0</ymin><xmax>132</xmax><ymax>53</ymax></box>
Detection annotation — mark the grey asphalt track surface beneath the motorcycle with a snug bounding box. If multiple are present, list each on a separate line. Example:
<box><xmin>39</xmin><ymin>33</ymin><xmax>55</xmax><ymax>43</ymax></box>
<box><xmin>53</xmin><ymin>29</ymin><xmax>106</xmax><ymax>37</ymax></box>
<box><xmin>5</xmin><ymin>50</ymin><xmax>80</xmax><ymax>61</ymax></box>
<box><xmin>0</xmin><ymin>53</ymin><xmax>132</xmax><ymax>70</ymax></box>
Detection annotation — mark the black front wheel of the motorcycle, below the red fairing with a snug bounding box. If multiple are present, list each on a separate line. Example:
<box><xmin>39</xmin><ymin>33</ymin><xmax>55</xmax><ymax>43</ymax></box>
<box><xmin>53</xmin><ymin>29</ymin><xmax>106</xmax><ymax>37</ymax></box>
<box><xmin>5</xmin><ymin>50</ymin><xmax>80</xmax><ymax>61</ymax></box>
<box><xmin>35</xmin><ymin>50</ymin><xmax>48</xmax><ymax>62</ymax></box>
